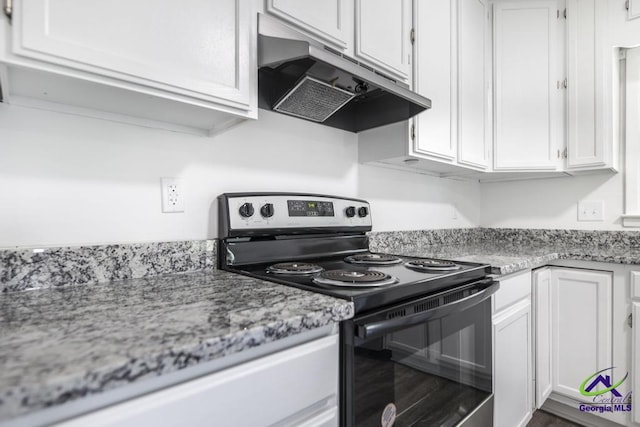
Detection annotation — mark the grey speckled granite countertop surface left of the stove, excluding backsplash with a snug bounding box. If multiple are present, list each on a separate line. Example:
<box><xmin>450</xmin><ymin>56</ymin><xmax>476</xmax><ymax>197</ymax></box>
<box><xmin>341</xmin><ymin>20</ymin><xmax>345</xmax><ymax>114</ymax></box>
<box><xmin>0</xmin><ymin>270</ymin><xmax>354</xmax><ymax>423</ymax></box>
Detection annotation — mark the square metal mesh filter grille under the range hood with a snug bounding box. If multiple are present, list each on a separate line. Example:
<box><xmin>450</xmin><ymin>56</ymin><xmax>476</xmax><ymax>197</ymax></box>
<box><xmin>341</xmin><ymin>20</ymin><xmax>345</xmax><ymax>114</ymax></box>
<box><xmin>273</xmin><ymin>76</ymin><xmax>354</xmax><ymax>123</ymax></box>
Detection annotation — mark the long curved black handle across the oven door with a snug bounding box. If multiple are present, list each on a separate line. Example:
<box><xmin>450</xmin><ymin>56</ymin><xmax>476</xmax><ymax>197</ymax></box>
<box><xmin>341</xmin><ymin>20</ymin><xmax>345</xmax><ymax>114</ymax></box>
<box><xmin>354</xmin><ymin>279</ymin><xmax>500</xmax><ymax>339</ymax></box>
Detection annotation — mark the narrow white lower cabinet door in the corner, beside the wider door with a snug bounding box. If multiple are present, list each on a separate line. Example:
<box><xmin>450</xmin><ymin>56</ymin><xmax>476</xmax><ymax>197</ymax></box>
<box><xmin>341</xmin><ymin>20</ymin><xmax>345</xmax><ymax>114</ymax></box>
<box><xmin>533</xmin><ymin>268</ymin><xmax>552</xmax><ymax>409</ymax></box>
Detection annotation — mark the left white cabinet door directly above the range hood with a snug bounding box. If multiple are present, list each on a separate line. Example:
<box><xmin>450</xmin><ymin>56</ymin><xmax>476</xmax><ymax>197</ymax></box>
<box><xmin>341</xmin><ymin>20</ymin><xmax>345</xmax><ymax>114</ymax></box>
<box><xmin>267</xmin><ymin>0</ymin><xmax>353</xmax><ymax>49</ymax></box>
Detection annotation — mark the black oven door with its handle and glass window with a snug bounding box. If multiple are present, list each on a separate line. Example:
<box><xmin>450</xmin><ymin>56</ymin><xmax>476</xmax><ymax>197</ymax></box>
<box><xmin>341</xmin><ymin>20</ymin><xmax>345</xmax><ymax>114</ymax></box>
<box><xmin>341</xmin><ymin>279</ymin><xmax>498</xmax><ymax>427</ymax></box>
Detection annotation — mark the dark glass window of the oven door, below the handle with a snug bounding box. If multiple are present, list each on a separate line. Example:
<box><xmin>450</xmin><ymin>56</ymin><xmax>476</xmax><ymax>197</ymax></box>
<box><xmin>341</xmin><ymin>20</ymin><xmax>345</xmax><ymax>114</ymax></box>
<box><xmin>352</xmin><ymin>300</ymin><xmax>492</xmax><ymax>426</ymax></box>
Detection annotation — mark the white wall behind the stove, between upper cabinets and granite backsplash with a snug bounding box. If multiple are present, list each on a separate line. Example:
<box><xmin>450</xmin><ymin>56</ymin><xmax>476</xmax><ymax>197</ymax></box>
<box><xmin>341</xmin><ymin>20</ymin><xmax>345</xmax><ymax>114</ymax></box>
<box><xmin>0</xmin><ymin>104</ymin><xmax>479</xmax><ymax>247</ymax></box>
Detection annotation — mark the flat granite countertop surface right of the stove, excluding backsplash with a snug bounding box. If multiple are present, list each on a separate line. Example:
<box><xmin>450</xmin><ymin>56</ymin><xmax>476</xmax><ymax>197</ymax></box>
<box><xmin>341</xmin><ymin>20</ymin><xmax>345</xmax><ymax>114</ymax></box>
<box><xmin>380</xmin><ymin>241</ymin><xmax>640</xmax><ymax>274</ymax></box>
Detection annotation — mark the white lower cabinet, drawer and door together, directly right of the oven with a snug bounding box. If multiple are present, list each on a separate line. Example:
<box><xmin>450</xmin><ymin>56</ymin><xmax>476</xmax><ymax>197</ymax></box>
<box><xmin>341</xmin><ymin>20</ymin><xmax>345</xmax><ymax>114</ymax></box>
<box><xmin>493</xmin><ymin>270</ymin><xmax>533</xmax><ymax>427</ymax></box>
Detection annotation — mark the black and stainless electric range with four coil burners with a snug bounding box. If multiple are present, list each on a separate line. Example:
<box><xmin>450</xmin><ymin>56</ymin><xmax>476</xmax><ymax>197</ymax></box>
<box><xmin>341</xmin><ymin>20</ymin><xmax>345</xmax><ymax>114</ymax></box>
<box><xmin>218</xmin><ymin>193</ymin><xmax>498</xmax><ymax>427</ymax></box>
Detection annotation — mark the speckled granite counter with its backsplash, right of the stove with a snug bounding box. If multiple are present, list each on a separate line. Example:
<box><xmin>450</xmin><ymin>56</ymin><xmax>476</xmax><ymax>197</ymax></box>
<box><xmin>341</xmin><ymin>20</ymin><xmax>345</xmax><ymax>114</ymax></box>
<box><xmin>370</xmin><ymin>228</ymin><xmax>640</xmax><ymax>274</ymax></box>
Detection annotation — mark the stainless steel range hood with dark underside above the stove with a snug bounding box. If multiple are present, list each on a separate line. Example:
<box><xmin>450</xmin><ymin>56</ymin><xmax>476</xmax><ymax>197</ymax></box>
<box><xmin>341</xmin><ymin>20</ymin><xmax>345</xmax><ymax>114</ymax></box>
<box><xmin>258</xmin><ymin>14</ymin><xmax>431</xmax><ymax>132</ymax></box>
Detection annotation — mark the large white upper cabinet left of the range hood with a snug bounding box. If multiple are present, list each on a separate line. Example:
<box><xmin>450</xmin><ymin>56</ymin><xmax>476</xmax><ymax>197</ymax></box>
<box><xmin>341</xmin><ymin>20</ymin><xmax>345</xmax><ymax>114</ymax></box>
<box><xmin>0</xmin><ymin>0</ymin><xmax>257</xmax><ymax>132</ymax></box>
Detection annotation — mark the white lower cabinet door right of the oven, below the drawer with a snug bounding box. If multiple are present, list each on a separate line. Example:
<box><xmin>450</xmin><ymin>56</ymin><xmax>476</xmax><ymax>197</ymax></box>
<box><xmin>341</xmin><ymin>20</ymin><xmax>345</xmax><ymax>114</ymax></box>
<box><xmin>493</xmin><ymin>298</ymin><xmax>533</xmax><ymax>427</ymax></box>
